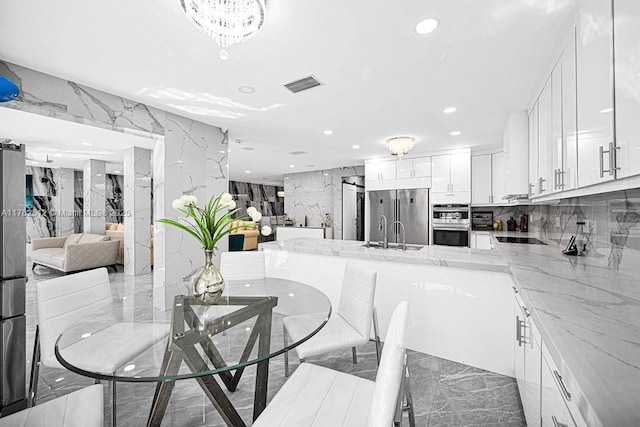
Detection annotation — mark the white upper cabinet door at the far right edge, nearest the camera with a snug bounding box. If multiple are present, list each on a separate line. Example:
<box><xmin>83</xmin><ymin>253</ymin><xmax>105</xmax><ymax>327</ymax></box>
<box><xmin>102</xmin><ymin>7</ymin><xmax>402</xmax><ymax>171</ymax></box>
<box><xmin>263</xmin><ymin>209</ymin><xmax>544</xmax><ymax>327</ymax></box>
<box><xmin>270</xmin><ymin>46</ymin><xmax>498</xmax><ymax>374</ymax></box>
<box><xmin>613</xmin><ymin>0</ymin><xmax>640</xmax><ymax>178</ymax></box>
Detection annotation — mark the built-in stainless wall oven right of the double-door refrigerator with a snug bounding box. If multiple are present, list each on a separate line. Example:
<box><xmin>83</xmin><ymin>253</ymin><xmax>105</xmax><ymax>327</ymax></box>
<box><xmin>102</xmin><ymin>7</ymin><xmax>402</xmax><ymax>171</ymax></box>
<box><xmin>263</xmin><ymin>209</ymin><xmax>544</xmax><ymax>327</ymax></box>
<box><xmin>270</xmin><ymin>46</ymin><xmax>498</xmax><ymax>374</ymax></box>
<box><xmin>431</xmin><ymin>204</ymin><xmax>470</xmax><ymax>247</ymax></box>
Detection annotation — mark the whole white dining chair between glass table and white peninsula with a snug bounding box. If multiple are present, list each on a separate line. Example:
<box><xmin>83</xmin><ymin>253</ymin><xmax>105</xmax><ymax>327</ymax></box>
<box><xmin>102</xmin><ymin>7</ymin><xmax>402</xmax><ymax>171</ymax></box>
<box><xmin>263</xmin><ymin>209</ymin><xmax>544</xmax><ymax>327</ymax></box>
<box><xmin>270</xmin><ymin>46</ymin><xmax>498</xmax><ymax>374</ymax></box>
<box><xmin>282</xmin><ymin>261</ymin><xmax>380</xmax><ymax>376</ymax></box>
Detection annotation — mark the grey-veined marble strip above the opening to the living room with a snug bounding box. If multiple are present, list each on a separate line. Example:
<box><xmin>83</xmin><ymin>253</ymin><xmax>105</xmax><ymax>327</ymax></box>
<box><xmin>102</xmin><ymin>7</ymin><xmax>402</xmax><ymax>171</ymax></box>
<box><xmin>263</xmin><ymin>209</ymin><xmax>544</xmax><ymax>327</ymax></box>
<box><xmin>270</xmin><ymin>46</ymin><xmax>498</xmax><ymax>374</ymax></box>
<box><xmin>0</xmin><ymin>61</ymin><xmax>164</xmax><ymax>136</ymax></box>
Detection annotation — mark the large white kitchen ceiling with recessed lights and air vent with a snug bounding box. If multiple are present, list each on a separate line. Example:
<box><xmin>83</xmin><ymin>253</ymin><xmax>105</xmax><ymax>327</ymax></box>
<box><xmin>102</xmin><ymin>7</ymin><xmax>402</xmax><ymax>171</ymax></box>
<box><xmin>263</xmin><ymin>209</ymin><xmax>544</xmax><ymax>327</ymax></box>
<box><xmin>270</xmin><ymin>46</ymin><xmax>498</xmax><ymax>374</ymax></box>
<box><xmin>0</xmin><ymin>0</ymin><xmax>576</xmax><ymax>181</ymax></box>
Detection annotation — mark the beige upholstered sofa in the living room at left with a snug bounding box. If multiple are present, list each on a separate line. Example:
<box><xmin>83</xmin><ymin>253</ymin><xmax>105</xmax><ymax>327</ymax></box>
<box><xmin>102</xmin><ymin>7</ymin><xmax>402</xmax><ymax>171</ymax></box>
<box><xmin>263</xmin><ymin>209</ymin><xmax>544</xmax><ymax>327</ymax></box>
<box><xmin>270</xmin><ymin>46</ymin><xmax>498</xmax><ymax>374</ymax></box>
<box><xmin>31</xmin><ymin>233</ymin><xmax>120</xmax><ymax>273</ymax></box>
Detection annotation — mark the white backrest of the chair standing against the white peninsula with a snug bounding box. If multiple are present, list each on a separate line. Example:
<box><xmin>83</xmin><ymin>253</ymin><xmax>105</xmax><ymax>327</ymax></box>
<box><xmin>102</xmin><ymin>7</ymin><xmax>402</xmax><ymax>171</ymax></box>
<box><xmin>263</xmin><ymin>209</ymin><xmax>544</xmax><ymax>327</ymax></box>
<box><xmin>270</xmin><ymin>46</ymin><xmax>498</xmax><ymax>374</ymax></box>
<box><xmin>338</xmin><ymin>261</ymin><xmax>376</xmax><ymax>338</ymax></box>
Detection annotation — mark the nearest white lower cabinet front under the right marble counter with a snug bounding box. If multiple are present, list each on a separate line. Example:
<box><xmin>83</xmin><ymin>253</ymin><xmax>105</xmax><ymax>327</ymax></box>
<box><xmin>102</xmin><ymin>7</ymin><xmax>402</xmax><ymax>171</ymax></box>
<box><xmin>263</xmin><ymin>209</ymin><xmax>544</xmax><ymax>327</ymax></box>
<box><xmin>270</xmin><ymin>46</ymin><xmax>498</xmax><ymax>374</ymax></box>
<box><xmin>541</xmin><ymin>355</ymin><xmax>576</xmax><ymax>427</ymax></box>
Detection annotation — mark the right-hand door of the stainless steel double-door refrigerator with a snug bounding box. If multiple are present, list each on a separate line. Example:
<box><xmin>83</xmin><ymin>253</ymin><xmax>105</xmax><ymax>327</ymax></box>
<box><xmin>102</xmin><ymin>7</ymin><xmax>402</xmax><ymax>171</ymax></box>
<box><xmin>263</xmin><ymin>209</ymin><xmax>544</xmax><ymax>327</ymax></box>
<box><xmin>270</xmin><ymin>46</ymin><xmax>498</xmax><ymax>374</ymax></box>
<box><xmin>398</xmin><ymin>189</ymin><xmax>429</xmax><ymax>245</ymax></box>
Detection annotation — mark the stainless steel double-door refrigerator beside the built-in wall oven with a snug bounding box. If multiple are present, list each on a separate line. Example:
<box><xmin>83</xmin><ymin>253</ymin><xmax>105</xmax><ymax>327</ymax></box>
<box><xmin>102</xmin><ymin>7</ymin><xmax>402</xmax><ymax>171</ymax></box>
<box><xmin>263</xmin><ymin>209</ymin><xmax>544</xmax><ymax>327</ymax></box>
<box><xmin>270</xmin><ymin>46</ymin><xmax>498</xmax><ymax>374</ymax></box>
<box><xmin>369</xmin><ymin>189</ymin><xmax>429</xmax><ymax>245</ymax></box>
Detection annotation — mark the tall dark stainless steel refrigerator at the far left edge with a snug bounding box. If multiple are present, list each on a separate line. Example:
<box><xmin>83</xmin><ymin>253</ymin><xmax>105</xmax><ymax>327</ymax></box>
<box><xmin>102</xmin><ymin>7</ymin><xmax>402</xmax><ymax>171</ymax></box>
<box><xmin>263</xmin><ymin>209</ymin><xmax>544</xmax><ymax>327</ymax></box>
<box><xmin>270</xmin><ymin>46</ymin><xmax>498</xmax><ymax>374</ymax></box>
<box><xmin>0</xmin><ymin>143</ymin><xmax>27</xmax><ymax>416</ymax></box>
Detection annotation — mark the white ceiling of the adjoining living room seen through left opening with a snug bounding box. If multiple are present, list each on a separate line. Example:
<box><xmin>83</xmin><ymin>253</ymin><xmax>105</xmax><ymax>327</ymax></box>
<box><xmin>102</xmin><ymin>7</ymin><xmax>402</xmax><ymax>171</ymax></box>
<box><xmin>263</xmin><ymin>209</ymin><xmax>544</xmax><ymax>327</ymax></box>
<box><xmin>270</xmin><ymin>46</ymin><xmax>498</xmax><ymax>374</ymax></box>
<box><xmin>0</xmin><ymin>108</ymin><xmax>153</xmax><ymax>174</ymax></box>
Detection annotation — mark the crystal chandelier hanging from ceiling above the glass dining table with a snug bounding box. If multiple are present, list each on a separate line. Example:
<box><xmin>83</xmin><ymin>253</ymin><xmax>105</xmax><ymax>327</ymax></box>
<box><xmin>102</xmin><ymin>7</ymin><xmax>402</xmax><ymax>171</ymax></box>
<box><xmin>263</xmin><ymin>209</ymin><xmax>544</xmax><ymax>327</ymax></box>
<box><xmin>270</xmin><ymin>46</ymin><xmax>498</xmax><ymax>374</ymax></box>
<box><xmin>180</xmin><ymin>0</ymin><xmax>266</xmax><ymax>49</ymax></box>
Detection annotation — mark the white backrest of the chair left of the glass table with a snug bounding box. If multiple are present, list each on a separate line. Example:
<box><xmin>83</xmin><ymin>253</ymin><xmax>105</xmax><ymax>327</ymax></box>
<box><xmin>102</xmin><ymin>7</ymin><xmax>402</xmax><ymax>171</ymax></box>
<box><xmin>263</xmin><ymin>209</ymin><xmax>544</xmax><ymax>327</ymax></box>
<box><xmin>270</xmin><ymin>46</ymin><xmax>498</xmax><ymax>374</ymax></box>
<box><xmin>36</xmin><ymin>268</ymin><xmax>113</xmax><ymax>364</ymax></box>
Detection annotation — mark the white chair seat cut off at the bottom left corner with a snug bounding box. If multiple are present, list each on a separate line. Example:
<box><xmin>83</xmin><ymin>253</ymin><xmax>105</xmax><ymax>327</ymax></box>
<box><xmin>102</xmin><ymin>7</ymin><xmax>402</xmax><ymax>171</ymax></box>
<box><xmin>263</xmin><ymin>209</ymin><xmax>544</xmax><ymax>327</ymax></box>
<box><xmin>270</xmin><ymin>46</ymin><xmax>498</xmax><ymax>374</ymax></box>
<box><xmin>0</xmin><ymin>384</ymin><xmax>104</xmax><ymax>427</ymax></box>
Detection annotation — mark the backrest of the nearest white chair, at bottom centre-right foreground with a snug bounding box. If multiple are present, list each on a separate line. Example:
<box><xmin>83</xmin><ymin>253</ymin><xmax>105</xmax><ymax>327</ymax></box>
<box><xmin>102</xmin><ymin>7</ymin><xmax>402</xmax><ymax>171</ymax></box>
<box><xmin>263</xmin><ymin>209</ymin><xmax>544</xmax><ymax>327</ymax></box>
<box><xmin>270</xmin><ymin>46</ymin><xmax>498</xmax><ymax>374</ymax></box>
<box><xmin>367</xmin><ymin>301</ymin><xmax>409</xmax><ymax>427</ymax></box>
